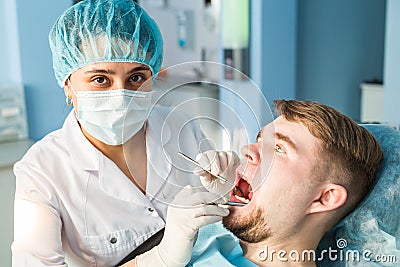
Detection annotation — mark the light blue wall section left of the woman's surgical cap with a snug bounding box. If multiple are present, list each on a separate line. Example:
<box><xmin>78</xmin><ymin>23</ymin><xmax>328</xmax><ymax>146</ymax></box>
<box><xmin>17</xmin><ymin>0</ymin><xmax>72</xmax><ymax>140</ymax></box>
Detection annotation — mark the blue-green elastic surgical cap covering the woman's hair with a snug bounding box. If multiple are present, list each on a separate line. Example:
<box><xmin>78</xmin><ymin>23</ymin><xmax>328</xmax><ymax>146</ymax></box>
<box><xmin>49</xmin><ymin>0</ymin><xmax>163</xmax><ymax>87</ymax></box>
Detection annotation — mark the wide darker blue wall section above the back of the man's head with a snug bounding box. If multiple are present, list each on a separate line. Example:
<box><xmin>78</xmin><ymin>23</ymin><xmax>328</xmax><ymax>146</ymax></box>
<box><xmin>297</xmin><ymin>0</ymin><xmax>386</xmax><ymax>120</ymax></box>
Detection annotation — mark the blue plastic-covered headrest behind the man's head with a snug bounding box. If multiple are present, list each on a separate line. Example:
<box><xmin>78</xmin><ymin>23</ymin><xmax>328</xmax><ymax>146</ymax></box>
<box><xmin>318</xmin><ymin>124</ymin><xmax>400</xmax><ymax>267</ymax></box>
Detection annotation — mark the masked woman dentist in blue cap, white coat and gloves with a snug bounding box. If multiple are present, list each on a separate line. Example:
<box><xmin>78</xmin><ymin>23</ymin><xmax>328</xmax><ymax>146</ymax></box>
<box><xmin>12</xmin><ymin>0</ymin><xmax>229</xmax><ymax>267</ymax></box>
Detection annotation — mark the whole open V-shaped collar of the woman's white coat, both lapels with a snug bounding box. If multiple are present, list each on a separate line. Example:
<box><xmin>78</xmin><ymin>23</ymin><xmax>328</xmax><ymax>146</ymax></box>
<box><xmin>63</xmin><ymin>110</ymin><xmax>172</xmax><ymax>204</ymax></box>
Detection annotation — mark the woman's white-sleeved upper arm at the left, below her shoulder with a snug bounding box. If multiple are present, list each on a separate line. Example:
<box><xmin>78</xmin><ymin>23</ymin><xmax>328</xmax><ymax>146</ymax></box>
<box><xmin>11</xmin><ymin>162</ymin><xmax>68</xmax><ymax>267</ymax></box>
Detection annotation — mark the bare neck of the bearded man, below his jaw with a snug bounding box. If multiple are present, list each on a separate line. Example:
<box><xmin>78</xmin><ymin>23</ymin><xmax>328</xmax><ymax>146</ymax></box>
<box><xmin>240</xmin><ymin>235</ymin><xmax>320</xmax><ymax>267</ymax></box>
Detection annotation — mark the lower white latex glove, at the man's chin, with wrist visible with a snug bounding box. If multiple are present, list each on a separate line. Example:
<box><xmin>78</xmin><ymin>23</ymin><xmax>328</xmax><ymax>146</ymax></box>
<box><xmin>135</xmin><ymin>186</ymin><xmax>229</xmax><ymax>267</ymax></box>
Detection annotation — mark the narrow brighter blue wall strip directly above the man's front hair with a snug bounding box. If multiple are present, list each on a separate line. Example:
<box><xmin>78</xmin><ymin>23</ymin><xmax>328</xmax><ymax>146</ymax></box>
<box><xmin>256</xmin><ymin>0</ymin><xmax>298</xmax><ymax>107</ymax></box>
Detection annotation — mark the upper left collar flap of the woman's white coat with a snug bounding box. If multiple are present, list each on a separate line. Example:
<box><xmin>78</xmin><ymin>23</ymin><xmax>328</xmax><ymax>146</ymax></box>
<box><xmin>62</xmin><ymin>110</ymin><xmax>101</xmax><ymax>170</ymax></box>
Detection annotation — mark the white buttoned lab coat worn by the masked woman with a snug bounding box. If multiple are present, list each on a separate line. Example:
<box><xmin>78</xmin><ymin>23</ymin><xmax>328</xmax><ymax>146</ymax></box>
<box><xmin>12</xmin><ymin>108</ymin><xmax>209</xmax><ymax>267</ymax></box>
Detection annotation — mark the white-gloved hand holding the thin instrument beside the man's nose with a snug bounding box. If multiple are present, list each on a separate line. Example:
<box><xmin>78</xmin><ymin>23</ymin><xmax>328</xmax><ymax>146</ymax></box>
<box><xmin>193</xmin><ymin>150</ymin><xmax>240</xmax><ymax>201</ymax></box>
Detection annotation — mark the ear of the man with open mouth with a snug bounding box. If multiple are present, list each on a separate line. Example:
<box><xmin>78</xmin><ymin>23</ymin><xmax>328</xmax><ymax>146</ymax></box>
<box><xmin>308</xmin><ymin>183</ymin><xmax>347</xmax><ymax>214</ymax></box>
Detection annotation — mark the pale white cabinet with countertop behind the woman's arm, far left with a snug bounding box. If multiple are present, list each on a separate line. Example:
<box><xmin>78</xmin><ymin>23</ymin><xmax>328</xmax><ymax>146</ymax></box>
<box><xmin>0</xmin><ymin>140</ymin><xmax>33</xmax><ymax>267</ymax></box>
